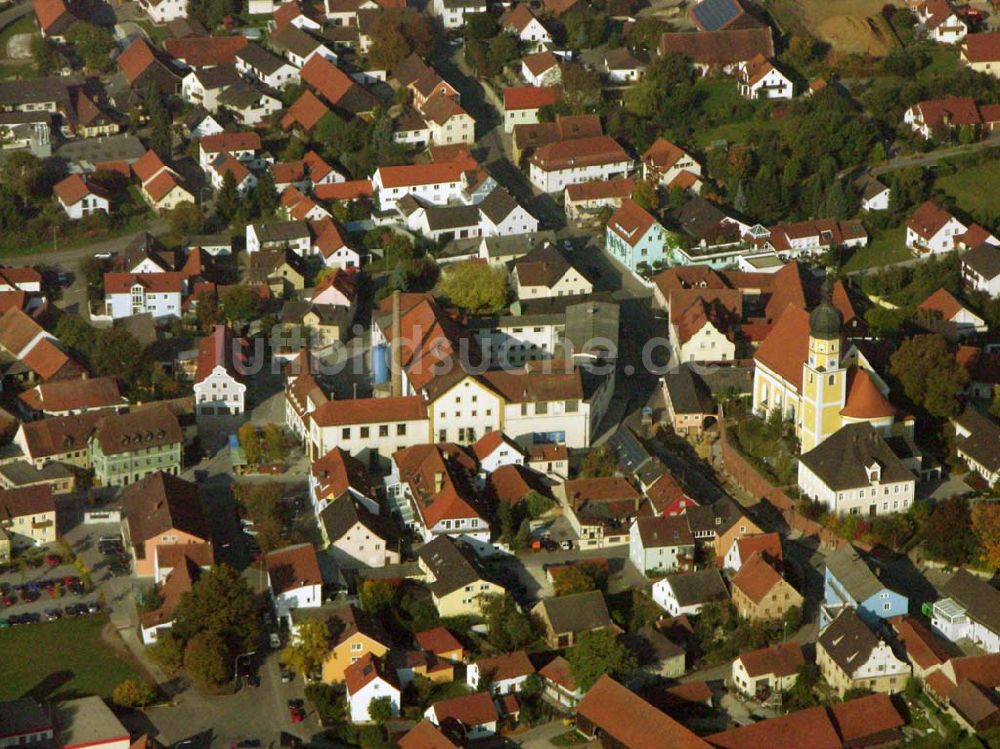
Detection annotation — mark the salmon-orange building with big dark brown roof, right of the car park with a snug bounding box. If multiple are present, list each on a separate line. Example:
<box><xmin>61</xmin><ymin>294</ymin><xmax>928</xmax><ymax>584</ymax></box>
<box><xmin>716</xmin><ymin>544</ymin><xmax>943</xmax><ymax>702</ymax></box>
<box><xmin>122</xmin><ymin>473</ymin><xmax>211</xmax><ymax>580</ymax></box>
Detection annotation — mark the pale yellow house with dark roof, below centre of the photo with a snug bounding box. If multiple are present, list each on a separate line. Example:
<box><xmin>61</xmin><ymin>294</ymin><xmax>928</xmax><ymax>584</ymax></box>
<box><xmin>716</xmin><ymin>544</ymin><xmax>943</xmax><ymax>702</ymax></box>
<box><xmin>417</xmin><ymin>536</ymin><xmax>507</xmax><ymax>616</ymax></box>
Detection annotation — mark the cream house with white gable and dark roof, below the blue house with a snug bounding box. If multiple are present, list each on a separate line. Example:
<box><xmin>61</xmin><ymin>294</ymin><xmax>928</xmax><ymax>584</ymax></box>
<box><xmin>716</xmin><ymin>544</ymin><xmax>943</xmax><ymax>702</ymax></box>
<box><xmin>816</xmin><ymin>608</ymin><xmax>911</xmax><ymax>697</ymax></box>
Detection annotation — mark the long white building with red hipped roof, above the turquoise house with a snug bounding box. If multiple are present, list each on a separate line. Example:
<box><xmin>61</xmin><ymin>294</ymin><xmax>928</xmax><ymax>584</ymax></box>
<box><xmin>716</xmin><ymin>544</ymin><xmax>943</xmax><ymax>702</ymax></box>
<box><xmin>528</xmin><ymin>135</ymin><xmax>632</xmax><ymax>193</ymax></box>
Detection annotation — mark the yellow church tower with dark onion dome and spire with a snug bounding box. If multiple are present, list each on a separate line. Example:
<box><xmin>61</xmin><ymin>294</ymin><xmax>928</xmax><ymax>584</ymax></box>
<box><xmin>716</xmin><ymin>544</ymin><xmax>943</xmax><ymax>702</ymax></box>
<box><xmin>799</xmin><ymin>279</ymin><xmax>847</xmax><ymax>453</ymax></box>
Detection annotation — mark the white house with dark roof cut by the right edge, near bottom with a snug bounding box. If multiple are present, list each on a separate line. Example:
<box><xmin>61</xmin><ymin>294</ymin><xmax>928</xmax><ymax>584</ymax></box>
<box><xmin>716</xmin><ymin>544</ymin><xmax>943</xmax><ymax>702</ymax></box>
<box><xmin>931</xmin><ymin>569</ymin><xmax>1000</xmax><ymax>653</ymax></box>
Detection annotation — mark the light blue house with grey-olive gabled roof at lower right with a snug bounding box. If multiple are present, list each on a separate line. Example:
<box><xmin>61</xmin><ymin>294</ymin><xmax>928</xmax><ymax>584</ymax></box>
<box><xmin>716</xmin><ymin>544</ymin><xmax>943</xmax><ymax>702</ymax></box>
<box><xmin>819</xmin><ymin>544</ymin><xmax>909</xmax><ymax>629</ymax></box>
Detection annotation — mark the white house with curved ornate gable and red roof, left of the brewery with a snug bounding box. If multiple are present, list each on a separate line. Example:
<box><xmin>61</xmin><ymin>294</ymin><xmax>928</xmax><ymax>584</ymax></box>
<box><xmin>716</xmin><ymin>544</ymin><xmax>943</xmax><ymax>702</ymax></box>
<box><xmin>194</xmin><ymin>325</ymin><xmax>247</xmax><ymax>416</ymax></box>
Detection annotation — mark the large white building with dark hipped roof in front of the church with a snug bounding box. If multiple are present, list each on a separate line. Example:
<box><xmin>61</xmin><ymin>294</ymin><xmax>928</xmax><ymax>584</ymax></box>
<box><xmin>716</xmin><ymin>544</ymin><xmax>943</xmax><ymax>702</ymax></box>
<box><xmin>798</xmin><ymin>424</ymin><xmax>917</xmax><ymax>516</ymax></box>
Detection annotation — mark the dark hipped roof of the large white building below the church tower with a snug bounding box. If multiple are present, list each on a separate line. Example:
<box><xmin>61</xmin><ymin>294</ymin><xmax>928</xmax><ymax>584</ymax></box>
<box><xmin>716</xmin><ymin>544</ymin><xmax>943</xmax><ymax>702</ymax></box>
<box><xmin>799</xmin><ymin>421</ymin><xmax>916</xmax><ymax>491</ymax></box>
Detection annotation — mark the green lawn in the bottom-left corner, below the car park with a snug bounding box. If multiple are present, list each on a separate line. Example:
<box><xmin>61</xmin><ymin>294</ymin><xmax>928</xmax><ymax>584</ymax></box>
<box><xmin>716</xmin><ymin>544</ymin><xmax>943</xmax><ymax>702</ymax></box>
<box><xmin>0</xmin><ymin>616</ymin><xmax>146</xmax><ymax>700</ymax></box>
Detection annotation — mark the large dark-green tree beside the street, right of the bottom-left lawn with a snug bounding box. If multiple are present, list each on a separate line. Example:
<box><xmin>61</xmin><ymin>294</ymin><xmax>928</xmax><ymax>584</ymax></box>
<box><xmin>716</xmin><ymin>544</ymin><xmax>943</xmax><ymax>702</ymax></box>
<box><xmin>172</xmin><ymin>564</ymin><xmax>260</xmax><ymax>665</ymax></box>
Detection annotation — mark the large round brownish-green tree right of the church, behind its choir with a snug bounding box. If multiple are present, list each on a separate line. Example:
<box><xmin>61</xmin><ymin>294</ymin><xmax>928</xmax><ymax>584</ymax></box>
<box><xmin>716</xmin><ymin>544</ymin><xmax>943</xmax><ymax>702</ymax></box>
<box><xmin>890</xmin><ymin>333</ymin><xmax>969</xmax><ymax>419</ymax></box>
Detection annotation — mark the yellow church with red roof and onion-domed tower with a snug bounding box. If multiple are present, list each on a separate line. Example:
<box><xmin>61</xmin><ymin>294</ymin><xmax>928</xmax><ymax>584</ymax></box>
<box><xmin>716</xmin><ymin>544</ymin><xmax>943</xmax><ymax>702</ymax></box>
<box><xmin>753</xmin><ymin>286</ymin><xmax>896</xmax><ymax>453</ymax></box>
